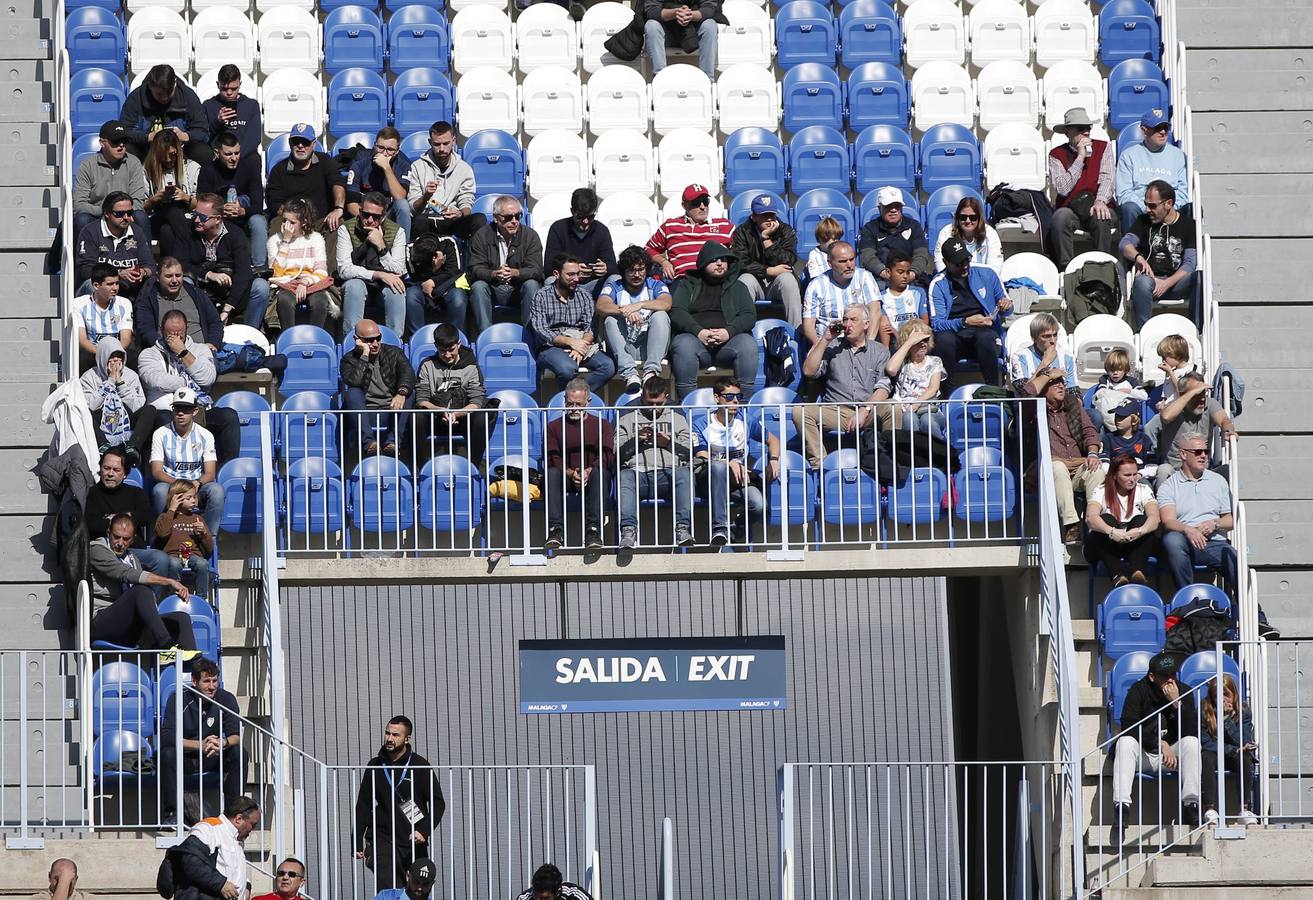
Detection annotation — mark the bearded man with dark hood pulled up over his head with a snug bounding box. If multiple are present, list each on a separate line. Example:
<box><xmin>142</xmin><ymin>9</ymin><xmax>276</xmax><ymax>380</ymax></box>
<box><xmin>670</xmin><ymin>240</ymin><xmax>758</xmax><ymax>399</ymax></box>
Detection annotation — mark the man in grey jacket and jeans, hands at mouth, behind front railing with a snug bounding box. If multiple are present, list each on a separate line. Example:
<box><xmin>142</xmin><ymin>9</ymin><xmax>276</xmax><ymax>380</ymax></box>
<box><xmin>616</xmin><ymin>376</ymin><xmax>693</xmax><ymax>551</ymax></box>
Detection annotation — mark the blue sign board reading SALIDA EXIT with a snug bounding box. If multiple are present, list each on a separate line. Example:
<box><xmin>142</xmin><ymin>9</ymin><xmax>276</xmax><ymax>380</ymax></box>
<box><xmin>520</xmin><ymin>635</ymin><xmax>789</xmax><ymax>715</ymax></box>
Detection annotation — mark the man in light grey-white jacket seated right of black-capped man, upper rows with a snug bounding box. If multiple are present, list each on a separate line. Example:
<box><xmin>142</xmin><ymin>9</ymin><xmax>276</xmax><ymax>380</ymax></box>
<box><xmin>406</xmin><ymin>122</ymin><xmax>487</xmax><ymax>242</ymax></box>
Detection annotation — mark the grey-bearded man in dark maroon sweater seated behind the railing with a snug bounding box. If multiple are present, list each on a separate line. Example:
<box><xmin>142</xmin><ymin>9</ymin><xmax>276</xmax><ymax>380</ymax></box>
<box><xmin>546</xmin><ymin>378</ymin><xmax>616</xmax><ymax>551</ymax></box>
